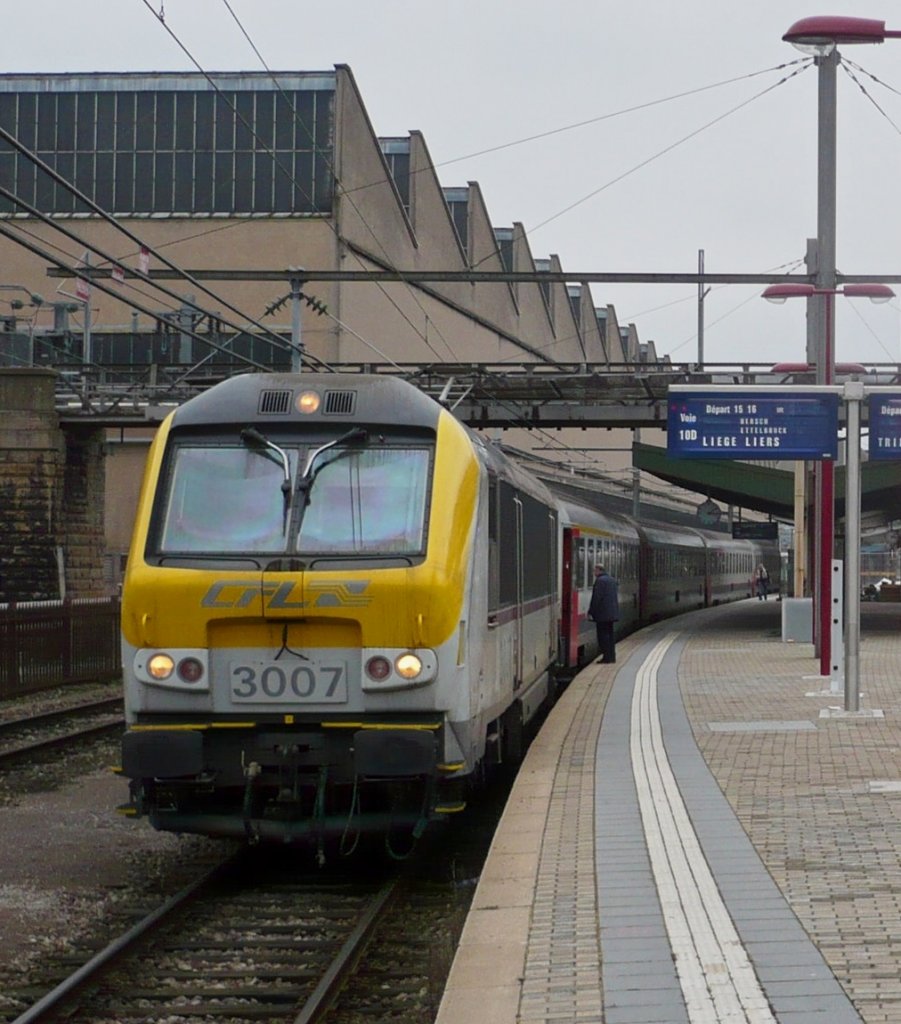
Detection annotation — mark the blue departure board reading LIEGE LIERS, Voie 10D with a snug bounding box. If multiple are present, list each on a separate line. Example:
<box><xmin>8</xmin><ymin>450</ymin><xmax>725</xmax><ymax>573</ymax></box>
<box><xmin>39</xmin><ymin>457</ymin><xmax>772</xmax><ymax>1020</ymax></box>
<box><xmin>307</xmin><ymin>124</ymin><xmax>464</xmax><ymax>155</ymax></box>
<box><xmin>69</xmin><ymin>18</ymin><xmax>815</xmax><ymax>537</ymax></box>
<box><xmin>667</xmin><ymin>387</ymin><xmax>839</xmax><ymax>461</ymax></box>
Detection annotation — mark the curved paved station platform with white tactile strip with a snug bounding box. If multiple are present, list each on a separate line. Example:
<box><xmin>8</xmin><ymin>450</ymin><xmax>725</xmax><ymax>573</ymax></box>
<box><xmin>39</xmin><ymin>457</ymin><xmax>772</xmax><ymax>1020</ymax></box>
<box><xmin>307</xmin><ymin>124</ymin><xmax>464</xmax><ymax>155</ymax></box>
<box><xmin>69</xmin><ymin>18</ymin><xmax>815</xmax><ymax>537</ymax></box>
<box><xmin>436</xmin><ymin>597</ymin><xmax>901</xmax><ymax>1024</ymax></box>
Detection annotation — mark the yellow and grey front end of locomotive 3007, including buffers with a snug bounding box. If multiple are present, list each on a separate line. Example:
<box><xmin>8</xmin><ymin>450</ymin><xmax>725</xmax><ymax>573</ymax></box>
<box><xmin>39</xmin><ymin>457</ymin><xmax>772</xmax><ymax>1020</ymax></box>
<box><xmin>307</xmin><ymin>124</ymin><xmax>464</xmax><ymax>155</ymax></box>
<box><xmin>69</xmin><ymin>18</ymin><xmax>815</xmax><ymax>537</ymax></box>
<box><xmin>122</xmin><ymin>374</ymin><xmax>479</xmax><ymax>841</ymax></box>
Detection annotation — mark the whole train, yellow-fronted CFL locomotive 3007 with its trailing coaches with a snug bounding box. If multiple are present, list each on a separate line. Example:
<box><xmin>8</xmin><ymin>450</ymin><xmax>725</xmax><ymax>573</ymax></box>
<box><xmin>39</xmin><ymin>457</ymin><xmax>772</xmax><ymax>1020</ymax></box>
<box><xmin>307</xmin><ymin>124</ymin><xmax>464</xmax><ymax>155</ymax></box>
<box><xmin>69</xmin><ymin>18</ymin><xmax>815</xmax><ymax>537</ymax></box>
<box><xmin>122</xmin><ymin>374</ymin><xmax>778</xmax><ymax>847</ymax></box>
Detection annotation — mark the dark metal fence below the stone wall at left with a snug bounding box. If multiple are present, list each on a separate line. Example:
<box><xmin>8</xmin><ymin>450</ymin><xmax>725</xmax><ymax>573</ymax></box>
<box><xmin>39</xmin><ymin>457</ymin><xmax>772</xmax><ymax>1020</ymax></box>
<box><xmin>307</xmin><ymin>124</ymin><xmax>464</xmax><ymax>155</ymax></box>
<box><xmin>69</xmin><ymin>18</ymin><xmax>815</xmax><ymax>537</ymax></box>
<box><xmin>0</xmin><ymin>597</ymin><xmax>122</xmax><ymax>698</ymax></box>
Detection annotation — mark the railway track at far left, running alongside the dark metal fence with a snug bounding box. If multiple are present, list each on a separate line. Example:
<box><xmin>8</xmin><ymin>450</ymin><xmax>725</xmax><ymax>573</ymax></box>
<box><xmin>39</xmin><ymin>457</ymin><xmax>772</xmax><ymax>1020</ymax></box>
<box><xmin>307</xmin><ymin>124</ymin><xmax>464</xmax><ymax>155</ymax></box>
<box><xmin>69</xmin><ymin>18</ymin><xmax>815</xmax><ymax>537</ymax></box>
<box><xmin>0</xmin><ymin>696</ymin><xmax>124</xmax><ymax>769</ymax></box>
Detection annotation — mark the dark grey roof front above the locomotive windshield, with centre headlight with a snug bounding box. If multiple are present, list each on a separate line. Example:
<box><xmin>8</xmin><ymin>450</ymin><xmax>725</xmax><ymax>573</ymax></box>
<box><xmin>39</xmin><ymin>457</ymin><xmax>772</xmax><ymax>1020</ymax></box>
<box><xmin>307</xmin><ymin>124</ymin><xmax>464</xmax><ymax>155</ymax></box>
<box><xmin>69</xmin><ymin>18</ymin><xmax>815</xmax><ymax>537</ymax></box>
<box><xmin>172</xmin><ymin>374</ymin><xmax>441</xmax><ymax>429</ymax></box>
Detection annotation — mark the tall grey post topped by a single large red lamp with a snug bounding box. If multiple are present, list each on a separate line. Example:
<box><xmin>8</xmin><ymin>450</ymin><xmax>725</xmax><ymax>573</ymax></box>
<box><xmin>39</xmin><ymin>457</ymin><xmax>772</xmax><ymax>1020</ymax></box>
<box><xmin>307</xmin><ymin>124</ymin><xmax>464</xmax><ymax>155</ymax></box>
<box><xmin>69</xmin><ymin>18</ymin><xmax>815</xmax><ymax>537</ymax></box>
<box><xmin>768</xmin><ymin>15</ymin><xmax>901</xmax><ymax>675</ymax></box>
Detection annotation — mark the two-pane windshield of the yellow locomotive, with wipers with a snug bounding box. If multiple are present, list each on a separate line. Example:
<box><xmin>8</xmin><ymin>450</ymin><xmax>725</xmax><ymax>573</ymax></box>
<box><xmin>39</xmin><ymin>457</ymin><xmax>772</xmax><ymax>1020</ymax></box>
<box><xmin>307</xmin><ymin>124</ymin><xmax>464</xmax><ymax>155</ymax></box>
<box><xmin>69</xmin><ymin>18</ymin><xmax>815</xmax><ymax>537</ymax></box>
<box><xmin>159</xmin><ymin>443</ymin><xmax>430</xmax><ymax>555</ymax></box>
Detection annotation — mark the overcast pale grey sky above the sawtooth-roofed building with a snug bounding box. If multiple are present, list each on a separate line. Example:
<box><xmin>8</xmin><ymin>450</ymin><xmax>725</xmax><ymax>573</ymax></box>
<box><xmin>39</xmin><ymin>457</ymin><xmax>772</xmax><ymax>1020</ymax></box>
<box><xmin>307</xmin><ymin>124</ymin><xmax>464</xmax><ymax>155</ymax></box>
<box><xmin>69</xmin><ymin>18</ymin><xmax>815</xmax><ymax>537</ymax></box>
<box><xmin>0</xmin><ymin>0</ymin><xmax>901</xmax><ymax>362</ymax></box>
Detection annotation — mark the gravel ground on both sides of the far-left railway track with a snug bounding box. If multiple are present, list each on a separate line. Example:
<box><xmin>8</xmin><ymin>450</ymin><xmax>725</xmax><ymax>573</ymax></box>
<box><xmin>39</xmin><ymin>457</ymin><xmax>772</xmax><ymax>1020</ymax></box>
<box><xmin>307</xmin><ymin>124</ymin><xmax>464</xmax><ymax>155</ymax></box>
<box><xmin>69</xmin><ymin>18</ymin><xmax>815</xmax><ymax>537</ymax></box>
<box><xmin>0</xmin><ymin>684</ymin><xmax>235</xmax><ymax>1016</ymax></box>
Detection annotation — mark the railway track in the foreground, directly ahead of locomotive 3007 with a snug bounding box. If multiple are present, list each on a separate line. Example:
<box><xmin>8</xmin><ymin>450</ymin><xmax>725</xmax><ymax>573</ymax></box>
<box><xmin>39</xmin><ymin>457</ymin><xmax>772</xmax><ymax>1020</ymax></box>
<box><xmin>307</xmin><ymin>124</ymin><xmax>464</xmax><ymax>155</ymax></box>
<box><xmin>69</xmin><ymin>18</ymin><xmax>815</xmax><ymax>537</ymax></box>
<box><xmin>4</xmin><ymin>851</ymin><xmax>396</xmax><ymax>1024</ymax></box>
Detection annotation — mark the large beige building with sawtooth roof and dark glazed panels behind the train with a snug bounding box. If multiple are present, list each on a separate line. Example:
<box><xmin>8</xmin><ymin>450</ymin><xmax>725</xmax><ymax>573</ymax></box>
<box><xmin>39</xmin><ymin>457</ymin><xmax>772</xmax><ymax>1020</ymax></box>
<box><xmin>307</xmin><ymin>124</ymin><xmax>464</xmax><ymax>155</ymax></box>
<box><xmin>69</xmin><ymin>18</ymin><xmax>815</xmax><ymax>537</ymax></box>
<box><xmin>0</xmin><ymin>66</ymin><xmax>683</xmax><ymax>598</ymax></box>
